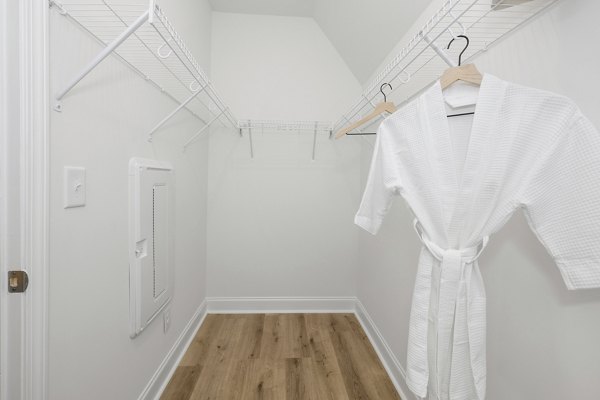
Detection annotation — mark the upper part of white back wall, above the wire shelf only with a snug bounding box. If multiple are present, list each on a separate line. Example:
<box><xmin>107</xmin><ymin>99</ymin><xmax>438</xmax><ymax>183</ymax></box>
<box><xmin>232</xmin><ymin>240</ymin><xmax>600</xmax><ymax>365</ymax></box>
<box><xmin>212</xmin><ymin>12</ymin><xmax>360</xmax><ymax>121</ymax></box>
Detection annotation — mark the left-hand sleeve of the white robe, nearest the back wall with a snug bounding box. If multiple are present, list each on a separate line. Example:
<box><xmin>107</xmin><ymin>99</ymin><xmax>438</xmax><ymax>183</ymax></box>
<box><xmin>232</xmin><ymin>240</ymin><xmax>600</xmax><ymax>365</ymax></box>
<box><xmin>354</xmin><ymin>123</ymin><xmax>400</xmax><ymax>235</ymax></box>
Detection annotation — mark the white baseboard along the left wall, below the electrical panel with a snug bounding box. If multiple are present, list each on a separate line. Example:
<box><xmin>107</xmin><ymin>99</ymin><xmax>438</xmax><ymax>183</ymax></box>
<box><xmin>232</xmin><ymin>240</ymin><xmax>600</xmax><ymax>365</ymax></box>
<box><xmin>138</xmin><ymin>301</ymin><xmax>207</xmax><ymax>400</ymax></box>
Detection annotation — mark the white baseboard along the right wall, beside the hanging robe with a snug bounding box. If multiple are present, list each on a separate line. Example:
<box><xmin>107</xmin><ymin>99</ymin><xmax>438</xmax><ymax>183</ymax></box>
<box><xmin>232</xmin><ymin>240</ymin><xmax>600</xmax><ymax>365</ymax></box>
<box><xmin>355</xmin><ymin>299</ymin><xmax>417</xmax><ymax>400</ymax></box>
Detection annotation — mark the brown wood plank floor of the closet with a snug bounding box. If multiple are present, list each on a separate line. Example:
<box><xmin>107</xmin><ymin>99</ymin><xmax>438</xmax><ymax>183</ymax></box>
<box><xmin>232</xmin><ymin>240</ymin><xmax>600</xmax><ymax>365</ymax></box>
<box><xmin>161</xmin><ymin>314</ymin><xmax>400</xmax><ymax>400</ymax></box>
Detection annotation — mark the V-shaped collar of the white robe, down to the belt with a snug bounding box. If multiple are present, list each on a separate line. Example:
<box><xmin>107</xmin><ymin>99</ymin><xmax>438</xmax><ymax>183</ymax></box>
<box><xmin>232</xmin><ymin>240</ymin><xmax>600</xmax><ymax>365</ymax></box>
<box><xmin>418</xmin><ymin>74</ymin><xmax>507</xmax><ymax>248</ymax></box>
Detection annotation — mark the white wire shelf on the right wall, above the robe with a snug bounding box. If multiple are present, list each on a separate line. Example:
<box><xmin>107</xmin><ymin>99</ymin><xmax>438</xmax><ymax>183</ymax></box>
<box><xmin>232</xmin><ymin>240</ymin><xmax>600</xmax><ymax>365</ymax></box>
<box><xmin>334</xmin><ymin>0</ymin><xmax>558</xmax><ymax>132</ymax></box>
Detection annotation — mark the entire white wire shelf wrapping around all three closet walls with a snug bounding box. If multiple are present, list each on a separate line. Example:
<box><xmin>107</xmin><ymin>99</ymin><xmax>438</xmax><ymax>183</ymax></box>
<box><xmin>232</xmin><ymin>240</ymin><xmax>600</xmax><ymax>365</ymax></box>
<box><xmin>50</xmin><ymin>0</ymin><xmax>558</xmax><ymax>147</ymax></box>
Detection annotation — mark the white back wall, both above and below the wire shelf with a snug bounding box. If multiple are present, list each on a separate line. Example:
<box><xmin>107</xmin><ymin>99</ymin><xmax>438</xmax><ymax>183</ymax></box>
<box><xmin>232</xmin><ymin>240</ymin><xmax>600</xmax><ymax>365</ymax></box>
<box><xmin>208</xmin><ymin>13</ymin><xmax>360</xmax><ymax>297</ymax></box>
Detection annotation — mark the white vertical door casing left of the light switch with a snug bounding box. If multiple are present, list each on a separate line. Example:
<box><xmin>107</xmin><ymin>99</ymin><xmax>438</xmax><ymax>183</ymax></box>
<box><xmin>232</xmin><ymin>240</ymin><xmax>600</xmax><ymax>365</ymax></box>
<box><xmin>19</xmin><ymin>0</ymin><xmax>49</xmax><ymax>400</ymax></box>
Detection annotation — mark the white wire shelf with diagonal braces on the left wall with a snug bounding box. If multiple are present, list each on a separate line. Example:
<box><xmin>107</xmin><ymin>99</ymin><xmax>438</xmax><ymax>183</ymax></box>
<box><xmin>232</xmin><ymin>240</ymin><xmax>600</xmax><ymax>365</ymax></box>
<box><xmin>50</xmin><ymin>0</ymin><xmax>238</xmax><ymax>142</ymax></box>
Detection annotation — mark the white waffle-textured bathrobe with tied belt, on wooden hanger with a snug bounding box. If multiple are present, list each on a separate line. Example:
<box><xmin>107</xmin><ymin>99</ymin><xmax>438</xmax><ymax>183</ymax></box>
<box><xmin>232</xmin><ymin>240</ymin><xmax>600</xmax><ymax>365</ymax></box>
<box><xmin>355</xmin><ymin>75</ymin><xmax>600</xmax><ymax>400</ymax></box>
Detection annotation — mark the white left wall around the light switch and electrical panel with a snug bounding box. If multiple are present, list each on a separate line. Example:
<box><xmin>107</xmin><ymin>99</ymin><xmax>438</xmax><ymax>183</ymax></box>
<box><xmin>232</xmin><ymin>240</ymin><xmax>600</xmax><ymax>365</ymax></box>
<box><xmin>49</xmin><ymin>0</ymin><xmax>211</xmax><ymax>400</ymax></box>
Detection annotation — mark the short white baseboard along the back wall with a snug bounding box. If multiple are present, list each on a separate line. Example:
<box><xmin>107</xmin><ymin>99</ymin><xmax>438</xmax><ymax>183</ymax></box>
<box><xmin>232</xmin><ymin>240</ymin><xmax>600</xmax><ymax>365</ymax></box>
<box><xmin>206</xmin><ymin>297</ymin><xmax>356</xmax><ymax>314</ymax></box>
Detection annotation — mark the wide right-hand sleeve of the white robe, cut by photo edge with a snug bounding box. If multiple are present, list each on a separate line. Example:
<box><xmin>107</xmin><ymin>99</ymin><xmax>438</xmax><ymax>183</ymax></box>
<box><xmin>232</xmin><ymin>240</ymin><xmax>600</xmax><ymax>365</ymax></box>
<box><xmin>523</xmin><ymin>111</ymin><xmax>600</xmax><ymax>289</ymax></box>
